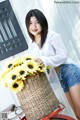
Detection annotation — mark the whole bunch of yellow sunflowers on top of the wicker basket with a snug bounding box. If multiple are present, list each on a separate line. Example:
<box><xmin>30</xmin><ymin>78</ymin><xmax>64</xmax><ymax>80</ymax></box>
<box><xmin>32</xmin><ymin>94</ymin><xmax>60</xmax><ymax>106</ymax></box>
<box><xmin>1</xmin><ymin>56</ymin><xmax>45</xmax><ymax>93</ymax></box>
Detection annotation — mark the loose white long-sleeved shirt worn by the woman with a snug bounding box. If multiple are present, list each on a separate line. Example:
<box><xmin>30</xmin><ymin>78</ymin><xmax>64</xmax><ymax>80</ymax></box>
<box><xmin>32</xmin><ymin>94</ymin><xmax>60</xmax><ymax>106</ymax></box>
<box><xmin>30</xmin><ymin>31</ymin><xmax>68</xmax><ymax>67</ymax></box>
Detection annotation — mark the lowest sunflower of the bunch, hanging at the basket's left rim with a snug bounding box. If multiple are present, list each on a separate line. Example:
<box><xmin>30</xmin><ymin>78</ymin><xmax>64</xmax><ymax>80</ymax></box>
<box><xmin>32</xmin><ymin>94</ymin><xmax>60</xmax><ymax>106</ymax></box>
<box><xmin>8</xmin><ymin>81</ymin><xmax>24</xmax><ymax>93</ymax></box>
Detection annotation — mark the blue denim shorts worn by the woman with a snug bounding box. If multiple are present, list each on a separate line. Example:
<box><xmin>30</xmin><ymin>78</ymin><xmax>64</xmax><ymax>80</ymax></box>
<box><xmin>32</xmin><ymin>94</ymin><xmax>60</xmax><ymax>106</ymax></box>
<box><xmin>58</xmin><ymin>64</ymin><xmax>80</xmax><ymax>92</ymax></box>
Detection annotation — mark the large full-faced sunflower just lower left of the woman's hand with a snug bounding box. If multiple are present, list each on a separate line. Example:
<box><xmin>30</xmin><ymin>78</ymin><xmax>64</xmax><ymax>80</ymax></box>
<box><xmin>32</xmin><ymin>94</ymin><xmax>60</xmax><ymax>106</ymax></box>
<box><xmin>23</xmin><ymin>60</ymin><xmax>38</xmax><ymax>74</ymax></box>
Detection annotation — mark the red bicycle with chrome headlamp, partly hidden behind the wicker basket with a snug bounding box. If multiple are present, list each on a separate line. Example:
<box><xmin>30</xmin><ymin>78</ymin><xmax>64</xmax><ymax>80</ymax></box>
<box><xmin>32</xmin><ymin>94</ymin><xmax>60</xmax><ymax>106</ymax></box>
<box><xmin>1</xmin><ymin>104</ymin><xmax>75</xmax><ymax>120</ymax></box>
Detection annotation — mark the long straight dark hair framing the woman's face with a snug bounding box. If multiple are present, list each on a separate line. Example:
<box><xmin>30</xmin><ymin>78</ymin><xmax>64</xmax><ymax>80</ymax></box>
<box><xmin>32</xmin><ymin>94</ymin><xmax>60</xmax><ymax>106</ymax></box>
<box><xmin>25</xmin><ymin>9</ymin><xmax>48</xmax><ymax>48</ymax></box>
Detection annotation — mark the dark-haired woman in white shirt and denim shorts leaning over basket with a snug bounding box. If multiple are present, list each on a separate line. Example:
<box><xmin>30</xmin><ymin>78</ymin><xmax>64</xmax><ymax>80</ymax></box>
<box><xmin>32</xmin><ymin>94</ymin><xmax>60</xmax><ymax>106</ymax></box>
<box><xmin>25</xmin><ymin>9</ymin><xmax>80</xmax><ymax>118</ymax></box>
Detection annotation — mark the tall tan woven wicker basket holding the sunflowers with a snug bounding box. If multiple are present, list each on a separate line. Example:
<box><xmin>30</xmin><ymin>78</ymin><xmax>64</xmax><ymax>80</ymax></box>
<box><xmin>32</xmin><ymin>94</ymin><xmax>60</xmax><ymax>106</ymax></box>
<box><xmin>17</xmin><ymin>73</ymin><xmax>59</xmax><ymax>120</ymax></box>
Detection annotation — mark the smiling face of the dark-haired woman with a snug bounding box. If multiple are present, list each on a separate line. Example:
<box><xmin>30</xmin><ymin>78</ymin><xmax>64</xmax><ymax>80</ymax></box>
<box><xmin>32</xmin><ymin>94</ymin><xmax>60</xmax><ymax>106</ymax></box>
<box><xmin>29</xmin><ymin>16</ymin><xmax>42</xmax><ymax>36</ymax></box>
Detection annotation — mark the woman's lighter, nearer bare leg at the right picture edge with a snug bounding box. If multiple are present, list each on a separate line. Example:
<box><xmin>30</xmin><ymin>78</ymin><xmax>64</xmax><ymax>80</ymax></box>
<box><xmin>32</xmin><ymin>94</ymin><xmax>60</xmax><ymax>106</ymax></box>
<box><xmin>69</xmin><ymin>84</ymin><xmax>80</xmax><ymax>119</ymax></box>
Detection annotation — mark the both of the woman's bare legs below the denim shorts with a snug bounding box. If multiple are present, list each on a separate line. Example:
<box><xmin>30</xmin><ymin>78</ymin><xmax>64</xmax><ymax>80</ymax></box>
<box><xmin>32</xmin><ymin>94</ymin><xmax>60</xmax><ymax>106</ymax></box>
<box><xmin>65</xmin><ymin>84</ymin><xmax>80</xmax><ymax>119</ymax></box>
